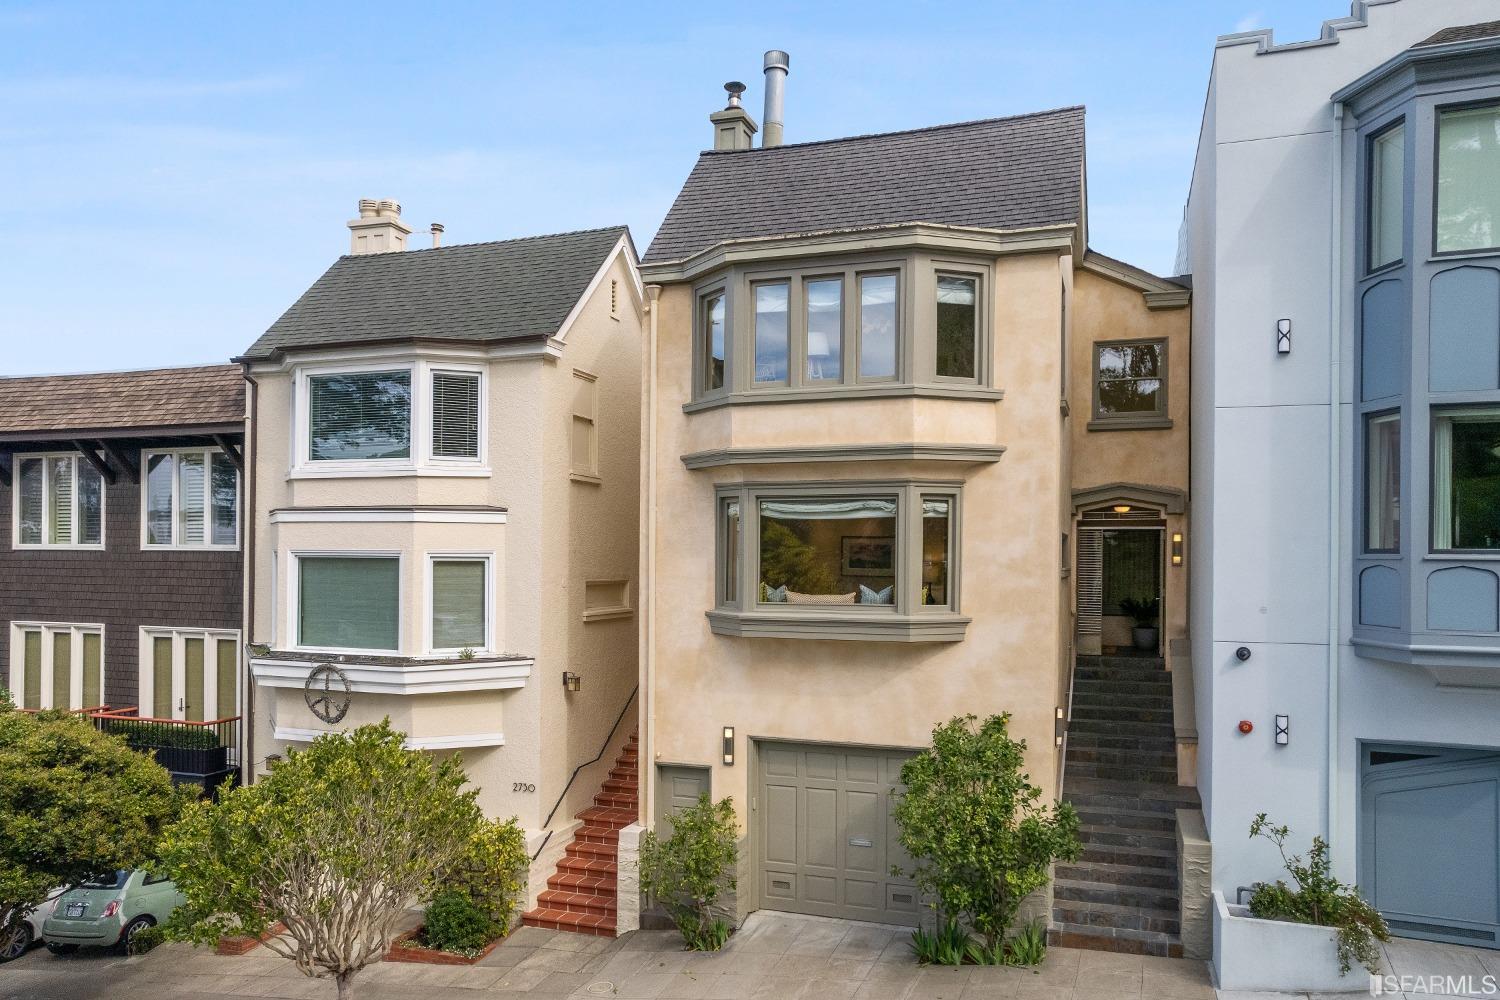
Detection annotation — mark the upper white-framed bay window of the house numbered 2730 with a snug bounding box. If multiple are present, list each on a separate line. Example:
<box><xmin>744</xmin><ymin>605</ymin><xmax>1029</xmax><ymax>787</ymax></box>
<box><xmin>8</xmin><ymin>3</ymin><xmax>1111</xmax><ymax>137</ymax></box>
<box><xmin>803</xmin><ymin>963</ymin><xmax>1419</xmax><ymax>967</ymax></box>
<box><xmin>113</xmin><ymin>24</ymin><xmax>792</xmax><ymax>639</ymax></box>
<box><xmin>296</xmin><ymin>361</ymin><xmax>485</xmax><ymax>475</ymax></box>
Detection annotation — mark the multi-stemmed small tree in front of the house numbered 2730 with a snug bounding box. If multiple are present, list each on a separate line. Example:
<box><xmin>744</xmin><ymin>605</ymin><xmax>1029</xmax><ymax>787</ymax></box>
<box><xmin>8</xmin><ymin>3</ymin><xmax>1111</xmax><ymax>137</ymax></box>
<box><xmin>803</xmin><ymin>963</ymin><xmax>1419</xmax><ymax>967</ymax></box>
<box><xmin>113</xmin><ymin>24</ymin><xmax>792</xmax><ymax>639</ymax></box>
<box><xmin>162</xmin><ymin>720</ymin><xmax>485</xmax><ymax>1000</ymax></box>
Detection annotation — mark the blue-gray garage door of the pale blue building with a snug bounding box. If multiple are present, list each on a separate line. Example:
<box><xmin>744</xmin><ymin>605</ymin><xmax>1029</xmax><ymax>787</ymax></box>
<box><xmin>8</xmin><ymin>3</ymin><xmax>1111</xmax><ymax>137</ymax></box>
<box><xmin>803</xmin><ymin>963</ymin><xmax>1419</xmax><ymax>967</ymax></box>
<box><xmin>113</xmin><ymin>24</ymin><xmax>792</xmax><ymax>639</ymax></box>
<box><xmin>1359</xmin><ymin>747</ymin><xmax>1500</xmax><ymax>948</ymax></box>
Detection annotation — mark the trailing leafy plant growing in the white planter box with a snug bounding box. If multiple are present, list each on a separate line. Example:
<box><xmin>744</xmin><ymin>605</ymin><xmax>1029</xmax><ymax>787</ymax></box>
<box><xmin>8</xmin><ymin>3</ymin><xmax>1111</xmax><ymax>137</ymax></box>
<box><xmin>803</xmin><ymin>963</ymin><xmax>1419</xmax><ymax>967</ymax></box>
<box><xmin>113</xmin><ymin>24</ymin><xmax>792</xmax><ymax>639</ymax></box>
<box><xmin>1250</xmin><ymin>813</ymin><xmax>1391</xmax><ymax>975</ymax></box>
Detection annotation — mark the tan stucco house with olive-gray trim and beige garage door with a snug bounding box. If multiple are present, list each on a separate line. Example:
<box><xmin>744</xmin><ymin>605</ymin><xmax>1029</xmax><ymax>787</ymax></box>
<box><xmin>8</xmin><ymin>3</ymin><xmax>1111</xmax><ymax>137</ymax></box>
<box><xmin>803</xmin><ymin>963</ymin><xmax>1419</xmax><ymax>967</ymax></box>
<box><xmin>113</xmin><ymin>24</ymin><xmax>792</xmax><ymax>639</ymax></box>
<box><xmin>623</xmin><ymin>78</ymin><xmax>1191</xmax><ymax>954</ymax></box>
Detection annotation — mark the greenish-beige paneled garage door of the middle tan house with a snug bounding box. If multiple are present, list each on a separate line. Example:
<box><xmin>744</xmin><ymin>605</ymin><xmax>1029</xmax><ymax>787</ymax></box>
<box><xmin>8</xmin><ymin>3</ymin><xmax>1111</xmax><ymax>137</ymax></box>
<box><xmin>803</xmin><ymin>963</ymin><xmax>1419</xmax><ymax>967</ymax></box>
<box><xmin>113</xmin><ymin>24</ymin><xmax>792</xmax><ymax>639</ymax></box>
<box><xmin>755</xmin><ymin>742</ymin><xmax>920</xmax><ymax>925</ymax></box>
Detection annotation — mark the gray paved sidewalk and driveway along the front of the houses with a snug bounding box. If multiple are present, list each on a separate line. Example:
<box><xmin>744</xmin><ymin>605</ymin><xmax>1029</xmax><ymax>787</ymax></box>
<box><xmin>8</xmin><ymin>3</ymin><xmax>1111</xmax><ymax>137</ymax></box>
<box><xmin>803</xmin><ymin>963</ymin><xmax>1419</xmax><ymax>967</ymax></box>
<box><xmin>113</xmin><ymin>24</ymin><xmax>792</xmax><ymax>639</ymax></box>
<box><xmin>0</xmin><ymin>912</ymin><xmax>1214</xmax><ymax>1000</ymax></box>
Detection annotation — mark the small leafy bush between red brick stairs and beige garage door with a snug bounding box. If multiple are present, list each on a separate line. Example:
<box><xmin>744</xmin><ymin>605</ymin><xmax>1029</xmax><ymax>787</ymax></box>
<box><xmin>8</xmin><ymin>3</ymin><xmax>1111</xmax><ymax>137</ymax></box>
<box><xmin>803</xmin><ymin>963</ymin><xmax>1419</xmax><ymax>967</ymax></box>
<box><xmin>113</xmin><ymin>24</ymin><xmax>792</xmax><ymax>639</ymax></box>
<box><xmin>639</xmin><ymin>793</ymin><xmax>738</xmax><ymax>952</ymax></box>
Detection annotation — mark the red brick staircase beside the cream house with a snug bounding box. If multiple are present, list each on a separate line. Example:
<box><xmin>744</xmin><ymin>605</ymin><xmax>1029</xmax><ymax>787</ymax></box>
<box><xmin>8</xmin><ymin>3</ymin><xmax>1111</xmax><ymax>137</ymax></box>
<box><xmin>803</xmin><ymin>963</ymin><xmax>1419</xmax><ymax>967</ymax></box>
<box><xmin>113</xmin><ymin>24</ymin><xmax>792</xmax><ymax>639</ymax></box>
<box><xmin>521</xmin><ymin>733</ymin><xmax>641</xmax><ymax>937</ymax></box>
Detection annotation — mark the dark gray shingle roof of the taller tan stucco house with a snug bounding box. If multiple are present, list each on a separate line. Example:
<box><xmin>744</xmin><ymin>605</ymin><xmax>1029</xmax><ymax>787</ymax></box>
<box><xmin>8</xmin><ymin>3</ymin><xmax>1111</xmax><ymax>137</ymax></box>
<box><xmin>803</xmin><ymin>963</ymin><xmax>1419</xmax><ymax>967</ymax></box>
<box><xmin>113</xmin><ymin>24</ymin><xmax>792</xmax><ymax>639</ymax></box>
<box><xmin>644</xmin><ymin>106</ymin><xmax>1083</xmax><ymax>264</ymax></box>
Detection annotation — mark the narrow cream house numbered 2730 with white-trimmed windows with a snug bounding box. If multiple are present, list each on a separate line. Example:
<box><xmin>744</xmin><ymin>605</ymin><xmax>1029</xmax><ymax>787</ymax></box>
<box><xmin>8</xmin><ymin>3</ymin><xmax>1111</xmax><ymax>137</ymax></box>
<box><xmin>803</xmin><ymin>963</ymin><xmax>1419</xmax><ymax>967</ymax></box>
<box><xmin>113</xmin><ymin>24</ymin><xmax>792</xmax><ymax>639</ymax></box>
<box><xmin>239</xmin><ymin>201</ymin><xmax>642</xmax><ymax>923</ymax></box>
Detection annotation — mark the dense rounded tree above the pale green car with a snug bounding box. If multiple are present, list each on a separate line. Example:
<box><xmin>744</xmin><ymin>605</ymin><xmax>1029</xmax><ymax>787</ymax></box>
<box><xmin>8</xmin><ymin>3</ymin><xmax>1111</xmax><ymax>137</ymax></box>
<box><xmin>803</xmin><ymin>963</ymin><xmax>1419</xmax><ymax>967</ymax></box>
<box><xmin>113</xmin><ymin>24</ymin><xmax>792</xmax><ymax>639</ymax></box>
<box><xmin>0</xmin><ymin>701</ymin><xmax>191</xmax><ymax>951</ymax></box>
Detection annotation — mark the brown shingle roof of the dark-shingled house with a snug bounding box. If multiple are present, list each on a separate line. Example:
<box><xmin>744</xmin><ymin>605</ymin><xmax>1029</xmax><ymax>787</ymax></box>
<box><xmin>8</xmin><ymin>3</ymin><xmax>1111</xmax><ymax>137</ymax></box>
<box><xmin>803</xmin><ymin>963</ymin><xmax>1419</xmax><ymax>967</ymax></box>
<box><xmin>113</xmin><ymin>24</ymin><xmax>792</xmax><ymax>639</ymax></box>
<box><xmin>0</xmin><ymin>364</ymin><xmax>245</xmax><ymax>435</ymax></box>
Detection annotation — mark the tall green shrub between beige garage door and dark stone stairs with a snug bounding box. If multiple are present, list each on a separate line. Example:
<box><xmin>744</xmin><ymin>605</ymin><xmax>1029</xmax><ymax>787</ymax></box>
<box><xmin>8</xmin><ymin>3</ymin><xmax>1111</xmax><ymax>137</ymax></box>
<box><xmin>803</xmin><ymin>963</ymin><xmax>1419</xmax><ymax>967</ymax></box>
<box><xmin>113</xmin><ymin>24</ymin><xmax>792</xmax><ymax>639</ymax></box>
<box><xmin>894</xmin><ymin>714</ymin><xmax>1082</xmax><ymax>955</ymax></box>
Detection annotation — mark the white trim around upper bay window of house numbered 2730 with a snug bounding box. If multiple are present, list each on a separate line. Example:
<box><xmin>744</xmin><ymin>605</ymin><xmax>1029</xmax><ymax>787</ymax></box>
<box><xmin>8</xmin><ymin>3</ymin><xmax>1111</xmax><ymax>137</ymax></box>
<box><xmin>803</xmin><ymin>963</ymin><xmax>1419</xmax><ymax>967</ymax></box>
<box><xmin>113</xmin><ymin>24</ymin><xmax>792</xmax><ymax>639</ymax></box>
<box><xmin>288</xmin><ymin>355</ymin><xmax>491</xmax><ymax>480</ymax></box>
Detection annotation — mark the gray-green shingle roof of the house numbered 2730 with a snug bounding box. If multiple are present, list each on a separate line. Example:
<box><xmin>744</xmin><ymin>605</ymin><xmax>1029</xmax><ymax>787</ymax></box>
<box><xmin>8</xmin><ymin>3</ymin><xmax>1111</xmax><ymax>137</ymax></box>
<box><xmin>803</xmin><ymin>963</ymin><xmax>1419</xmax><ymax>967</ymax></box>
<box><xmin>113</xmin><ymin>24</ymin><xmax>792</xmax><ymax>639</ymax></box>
<box><xmin>245</xmin><ymin>226</ymin><xmax>629</xmax><ymax>358</ymax></box>
